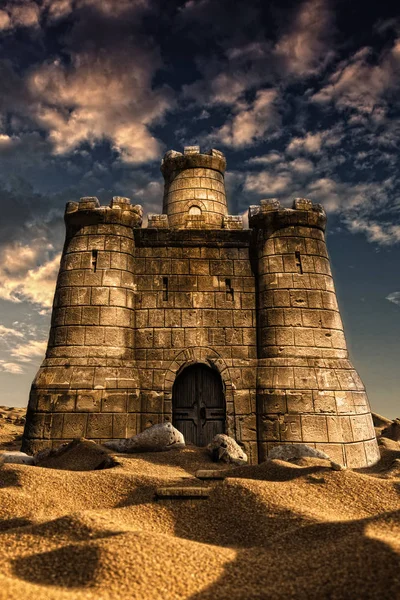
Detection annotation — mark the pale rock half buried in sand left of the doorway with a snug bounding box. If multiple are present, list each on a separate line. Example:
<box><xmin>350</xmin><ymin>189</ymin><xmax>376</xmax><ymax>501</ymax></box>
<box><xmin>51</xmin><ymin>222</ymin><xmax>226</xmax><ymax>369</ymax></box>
<box><xmin>104</xmin><ymin>423</ymin><xmax>185</xmax><ymax>452</ymax></box>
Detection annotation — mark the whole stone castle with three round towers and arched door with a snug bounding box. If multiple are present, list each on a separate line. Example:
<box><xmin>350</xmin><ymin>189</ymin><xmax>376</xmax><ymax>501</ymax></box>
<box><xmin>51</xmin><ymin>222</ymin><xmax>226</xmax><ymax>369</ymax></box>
<box><xmin>22</xmin><ymin>146</ymin><xmax>379</xmax><ymax>467</ymax></box>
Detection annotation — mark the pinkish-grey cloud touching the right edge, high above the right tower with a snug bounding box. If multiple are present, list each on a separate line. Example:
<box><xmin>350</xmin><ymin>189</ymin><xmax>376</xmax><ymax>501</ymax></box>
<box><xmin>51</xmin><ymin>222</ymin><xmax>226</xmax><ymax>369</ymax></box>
<box><xmin>311</xmin><ymin>38</ymin><xmax>400</xmax><ymax>115</ymax></box>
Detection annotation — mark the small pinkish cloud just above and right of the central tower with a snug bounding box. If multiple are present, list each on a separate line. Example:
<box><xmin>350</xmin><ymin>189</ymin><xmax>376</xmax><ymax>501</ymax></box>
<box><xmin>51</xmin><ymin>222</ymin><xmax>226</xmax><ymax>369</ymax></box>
<box><xmin>209</xmin><ymin>89</ymin><xmax>280</xmax><ymax>148</ymax></box>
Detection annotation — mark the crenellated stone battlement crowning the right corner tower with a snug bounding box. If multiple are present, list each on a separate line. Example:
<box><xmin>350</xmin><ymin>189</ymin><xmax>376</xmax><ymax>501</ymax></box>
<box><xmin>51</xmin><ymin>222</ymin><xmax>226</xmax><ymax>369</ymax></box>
<box><xmin>249</xmin><ymin>198</ymin><xmax>326</xmax><ymax>234</ymax></box>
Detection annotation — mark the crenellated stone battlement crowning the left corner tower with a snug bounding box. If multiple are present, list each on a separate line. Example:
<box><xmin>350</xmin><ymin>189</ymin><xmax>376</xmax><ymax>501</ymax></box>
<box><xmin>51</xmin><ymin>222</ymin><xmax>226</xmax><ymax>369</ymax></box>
<box><xmin>64</xmin><ymin>196</ymin><xmax>143</xmax><ymax>227</ymax></box>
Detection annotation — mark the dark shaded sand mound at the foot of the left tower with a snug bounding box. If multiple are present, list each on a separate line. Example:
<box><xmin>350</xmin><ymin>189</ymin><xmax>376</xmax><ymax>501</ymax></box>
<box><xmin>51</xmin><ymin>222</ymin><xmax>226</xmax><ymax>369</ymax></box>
<box><xmin>33</xmin><ymin>438</ymin><xmax>119</xmax><ymax>471</ymax></box>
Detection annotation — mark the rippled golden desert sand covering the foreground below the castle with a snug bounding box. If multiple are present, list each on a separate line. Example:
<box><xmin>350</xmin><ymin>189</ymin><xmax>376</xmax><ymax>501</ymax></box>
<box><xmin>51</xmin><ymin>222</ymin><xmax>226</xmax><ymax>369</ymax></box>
<box><xmin>0</xmin><ymin>407</ymin><xmax>400</xmax><ymax>600</ymax></box>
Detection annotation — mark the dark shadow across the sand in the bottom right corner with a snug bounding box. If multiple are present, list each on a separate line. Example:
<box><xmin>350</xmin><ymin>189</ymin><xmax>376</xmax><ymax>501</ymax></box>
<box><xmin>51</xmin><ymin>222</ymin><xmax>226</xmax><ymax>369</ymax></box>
<box><xmin>190</xmin><ymin>512</ymin><xmax>400</xmax><ymax>600</ymax></box>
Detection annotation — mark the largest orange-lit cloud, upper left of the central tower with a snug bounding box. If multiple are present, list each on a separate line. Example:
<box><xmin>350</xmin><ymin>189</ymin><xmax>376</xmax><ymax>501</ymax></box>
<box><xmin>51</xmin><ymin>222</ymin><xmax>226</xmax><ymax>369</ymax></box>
<box><xmin>27</xmin><ymin>46</ymin><xmax>172</xmax><ymax>163</ymax></box>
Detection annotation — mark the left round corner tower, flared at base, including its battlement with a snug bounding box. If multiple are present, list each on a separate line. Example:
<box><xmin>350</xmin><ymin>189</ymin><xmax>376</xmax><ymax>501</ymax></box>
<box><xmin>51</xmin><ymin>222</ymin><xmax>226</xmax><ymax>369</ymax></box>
<box><xmin>22</xmin><ymin>197</ymin><xmax>142</xmax><ymax>453</ymax></box>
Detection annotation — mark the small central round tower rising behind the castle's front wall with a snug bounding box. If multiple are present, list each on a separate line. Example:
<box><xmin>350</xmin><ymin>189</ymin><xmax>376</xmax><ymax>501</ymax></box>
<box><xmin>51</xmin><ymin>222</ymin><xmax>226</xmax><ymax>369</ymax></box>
<box><xmin>161</xmin><ymin>146</ymin><xmax>228</xmax><ymax>229</ymax></box>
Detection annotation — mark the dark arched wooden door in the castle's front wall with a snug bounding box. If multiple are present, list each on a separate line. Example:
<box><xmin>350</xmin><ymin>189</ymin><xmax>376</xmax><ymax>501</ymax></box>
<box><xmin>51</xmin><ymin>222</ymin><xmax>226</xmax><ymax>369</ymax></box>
<box><xmin>172</xmin><ymin>364</ymin><xmax>225</xmax><ymax>446</ymax></box>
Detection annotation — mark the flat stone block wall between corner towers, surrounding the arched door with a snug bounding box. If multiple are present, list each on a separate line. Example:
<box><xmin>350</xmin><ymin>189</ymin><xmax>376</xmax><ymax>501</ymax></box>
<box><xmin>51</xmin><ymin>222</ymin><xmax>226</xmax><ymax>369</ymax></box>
<box><xmin>134</xmin><ymin>229</ymin><xmax>257</xmax><ymax>462</ymax></box>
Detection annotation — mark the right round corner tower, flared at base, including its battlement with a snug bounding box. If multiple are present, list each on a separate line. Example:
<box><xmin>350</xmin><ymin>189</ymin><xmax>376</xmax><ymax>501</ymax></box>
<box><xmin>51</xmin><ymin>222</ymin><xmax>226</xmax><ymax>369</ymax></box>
<box><xmin>249</xmin><ymin>198</ymin><xmax>379</xmax><ymax>467</ymax></box>
